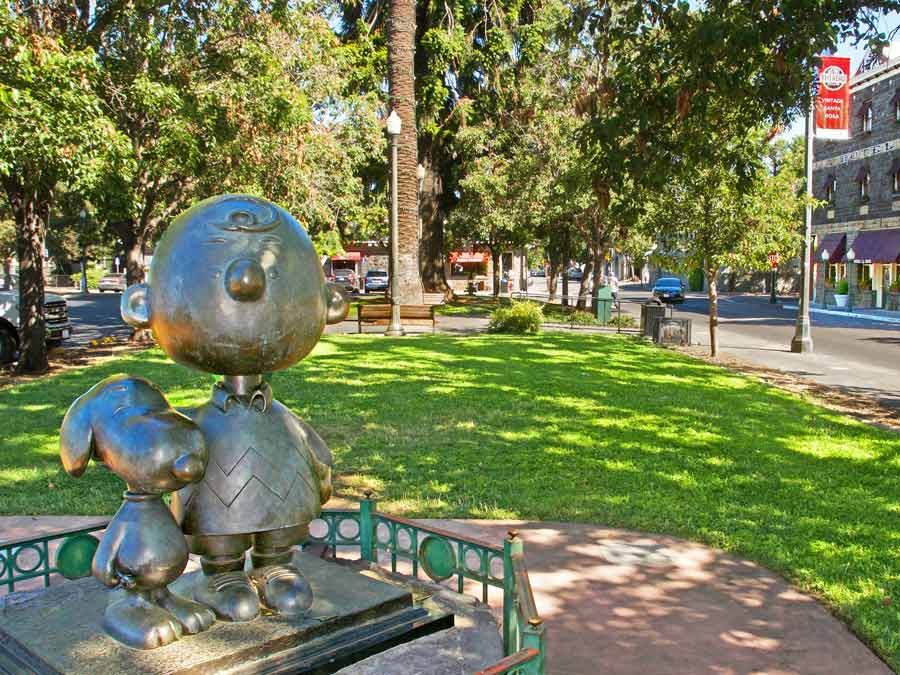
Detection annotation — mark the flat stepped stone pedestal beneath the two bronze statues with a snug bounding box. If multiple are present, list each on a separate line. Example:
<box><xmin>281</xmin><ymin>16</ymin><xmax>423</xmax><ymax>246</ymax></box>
<box><xmin>0</xmin><ymin>554</ymin><xmax>453</xmax><ymax>675</ymax></box>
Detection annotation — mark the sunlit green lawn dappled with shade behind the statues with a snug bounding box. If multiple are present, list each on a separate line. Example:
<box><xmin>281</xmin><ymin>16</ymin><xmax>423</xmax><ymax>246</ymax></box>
<box><xmin>0</xmin><ymin>333</ymin><xmax>900</xmax><ymax>667</ymax></box>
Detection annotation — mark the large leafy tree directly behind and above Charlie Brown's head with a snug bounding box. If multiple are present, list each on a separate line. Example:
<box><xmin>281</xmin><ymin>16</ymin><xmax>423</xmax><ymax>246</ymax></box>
<box><xmin>92</xmin><ymin>0</ymin><xmax>383</xmax><ymax>283</ymax></box>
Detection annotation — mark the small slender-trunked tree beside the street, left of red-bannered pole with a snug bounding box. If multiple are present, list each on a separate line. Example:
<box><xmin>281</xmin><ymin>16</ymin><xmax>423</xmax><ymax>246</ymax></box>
<box><xmin>642</xmin><ymin>134</ymin><xmax>805</xmax><ymax>357</ymax></box>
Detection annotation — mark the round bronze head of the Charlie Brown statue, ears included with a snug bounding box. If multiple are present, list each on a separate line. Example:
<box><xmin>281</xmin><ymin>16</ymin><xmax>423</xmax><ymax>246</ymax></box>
<box><xmin>122</xmin><ymin>195</ymin><xmax>349</xmax><ymax>375</ymax></box>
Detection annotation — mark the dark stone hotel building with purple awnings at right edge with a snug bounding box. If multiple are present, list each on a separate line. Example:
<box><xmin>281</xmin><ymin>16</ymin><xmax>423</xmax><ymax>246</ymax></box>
<box><xmin>813</xmin><ymin>43</ymin><xmax>900</xmax><ymax>310</ymax></box>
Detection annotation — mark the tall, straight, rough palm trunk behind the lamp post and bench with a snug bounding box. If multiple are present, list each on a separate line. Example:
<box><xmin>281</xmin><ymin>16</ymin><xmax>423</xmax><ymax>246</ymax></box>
<box><xmin>388</xmin><ymin>0</ymin><xmax>422</xmax><ymax>304</ymax></box>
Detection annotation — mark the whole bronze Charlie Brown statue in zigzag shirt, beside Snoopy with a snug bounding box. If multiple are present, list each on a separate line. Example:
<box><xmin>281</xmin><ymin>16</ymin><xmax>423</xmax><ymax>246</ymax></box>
<box><xmin>82</xmin><ymin>195</ymin><xmax>348</xmax><ymax>640</ymax></box>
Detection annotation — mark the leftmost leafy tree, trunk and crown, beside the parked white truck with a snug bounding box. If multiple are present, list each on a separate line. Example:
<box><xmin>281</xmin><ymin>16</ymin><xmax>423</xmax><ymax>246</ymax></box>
<box><xmin>0</xmin><ymin>11</ymin><xmax>116</xmax><ymax>372</ymax></box>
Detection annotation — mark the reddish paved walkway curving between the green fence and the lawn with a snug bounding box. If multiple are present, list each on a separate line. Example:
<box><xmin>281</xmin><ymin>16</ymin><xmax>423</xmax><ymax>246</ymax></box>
<box><xmin>0</xmin><ymin>516</ymin><xmax>891</xmax><ymax>675</ymax></box>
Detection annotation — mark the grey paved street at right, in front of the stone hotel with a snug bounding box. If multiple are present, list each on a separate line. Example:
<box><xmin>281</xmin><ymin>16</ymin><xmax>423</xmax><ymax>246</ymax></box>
<box><xmin>622</xmin><ymin>286</ymin><xmax>900</xmax><ymax>408</ymax></box>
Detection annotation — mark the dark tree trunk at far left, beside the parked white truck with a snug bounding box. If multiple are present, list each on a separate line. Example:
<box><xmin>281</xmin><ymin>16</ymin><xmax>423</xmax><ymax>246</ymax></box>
<box><xmin>7</xmin><ymin>189</ymin><xmax>50</xmax><ymax>373</ymax></box>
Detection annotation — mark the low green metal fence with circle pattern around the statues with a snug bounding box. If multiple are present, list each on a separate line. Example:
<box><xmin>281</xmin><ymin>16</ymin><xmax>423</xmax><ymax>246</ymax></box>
<box><xmin>0</xmin><ymin>495</ymin><xmax>546</xmax><ymax>675</ymax></box>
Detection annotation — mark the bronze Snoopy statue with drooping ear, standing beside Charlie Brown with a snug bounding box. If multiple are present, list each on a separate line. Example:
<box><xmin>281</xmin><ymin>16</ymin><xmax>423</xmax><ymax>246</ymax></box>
<box><xmin>60</xmin><ymin>375</ymin><xmax>215</xmax><ymax>649</ymax></box>
